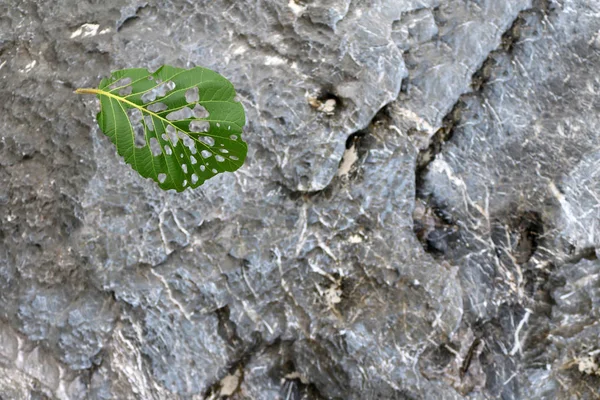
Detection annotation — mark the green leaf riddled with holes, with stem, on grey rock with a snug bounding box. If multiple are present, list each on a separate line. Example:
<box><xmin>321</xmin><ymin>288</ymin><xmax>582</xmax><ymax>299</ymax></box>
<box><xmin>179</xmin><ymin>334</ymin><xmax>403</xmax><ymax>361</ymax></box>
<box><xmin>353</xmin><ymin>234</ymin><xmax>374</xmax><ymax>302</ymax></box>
<box><xmin>76</xmin><ymin>65</ymin><xmax>247</xmax><ymax>192</ymax></box>
